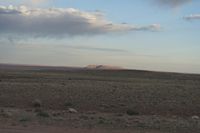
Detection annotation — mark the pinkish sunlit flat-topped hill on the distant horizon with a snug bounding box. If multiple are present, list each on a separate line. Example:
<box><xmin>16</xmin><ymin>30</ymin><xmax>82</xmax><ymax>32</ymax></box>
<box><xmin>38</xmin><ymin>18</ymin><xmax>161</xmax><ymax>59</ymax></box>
<box><xmin>85</xmin><ymin>65</ymin><xmax>123</xmax><ymax>70</ymax></box>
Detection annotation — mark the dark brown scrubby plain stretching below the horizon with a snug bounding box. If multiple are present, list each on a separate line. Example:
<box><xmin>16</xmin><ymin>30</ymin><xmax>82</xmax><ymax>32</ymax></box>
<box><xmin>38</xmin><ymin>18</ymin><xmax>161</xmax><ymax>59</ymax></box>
<box><xmin>0</xmin><ymin>66</ymin><xmax>200</xmax><ymax>133</ymax></box>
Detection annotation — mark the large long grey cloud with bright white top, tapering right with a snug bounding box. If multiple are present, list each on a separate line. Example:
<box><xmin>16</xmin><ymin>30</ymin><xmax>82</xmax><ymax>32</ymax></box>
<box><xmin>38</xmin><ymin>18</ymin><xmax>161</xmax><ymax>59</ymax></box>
<box><xmin>0</xmin><ymin>6</ymin><xmax>160</xmax><ymax>37</ymax></box>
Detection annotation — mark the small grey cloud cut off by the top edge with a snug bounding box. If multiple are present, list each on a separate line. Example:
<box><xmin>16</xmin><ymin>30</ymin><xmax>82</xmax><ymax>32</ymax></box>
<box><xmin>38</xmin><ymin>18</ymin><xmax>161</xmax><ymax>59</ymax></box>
<box><xmin>154</xmin><ymin>0</ymin><xmax>192</xmax><ymax>7</ymax></box>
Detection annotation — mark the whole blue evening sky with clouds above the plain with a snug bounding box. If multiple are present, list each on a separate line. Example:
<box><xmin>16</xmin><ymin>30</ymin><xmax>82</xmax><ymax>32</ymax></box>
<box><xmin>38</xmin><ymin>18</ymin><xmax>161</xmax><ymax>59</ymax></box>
<box><xmin>0</xmin><ymin>0</ymin><xmax>200</xmax><ymax>73</ymax></box>
